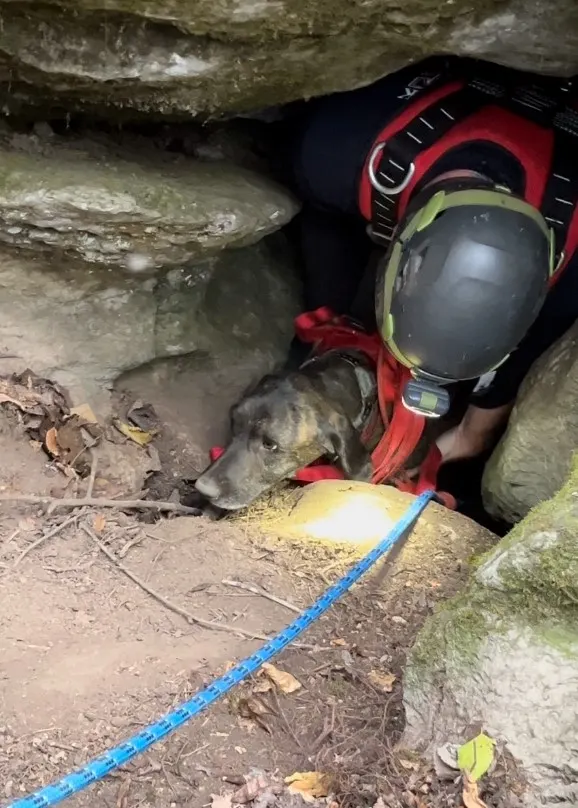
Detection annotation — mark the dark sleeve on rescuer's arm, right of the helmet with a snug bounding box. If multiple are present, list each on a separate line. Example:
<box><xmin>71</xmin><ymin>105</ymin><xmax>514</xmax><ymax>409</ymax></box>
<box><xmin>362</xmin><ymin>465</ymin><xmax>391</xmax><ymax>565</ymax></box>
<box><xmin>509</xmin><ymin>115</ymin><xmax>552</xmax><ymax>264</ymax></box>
<box><xmin>471</xmin><ymin>256</ymin><xmax>578</xmax><ymax>410</ymax></box>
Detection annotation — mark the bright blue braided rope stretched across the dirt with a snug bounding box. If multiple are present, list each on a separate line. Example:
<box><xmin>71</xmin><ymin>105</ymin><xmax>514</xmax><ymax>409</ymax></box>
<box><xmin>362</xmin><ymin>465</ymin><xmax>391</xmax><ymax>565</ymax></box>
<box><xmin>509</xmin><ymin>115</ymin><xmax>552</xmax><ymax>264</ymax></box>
<box><xmin>7</xmin><ymin>491</ymin><xmax>435</xmax><ymax>808</ymax></box>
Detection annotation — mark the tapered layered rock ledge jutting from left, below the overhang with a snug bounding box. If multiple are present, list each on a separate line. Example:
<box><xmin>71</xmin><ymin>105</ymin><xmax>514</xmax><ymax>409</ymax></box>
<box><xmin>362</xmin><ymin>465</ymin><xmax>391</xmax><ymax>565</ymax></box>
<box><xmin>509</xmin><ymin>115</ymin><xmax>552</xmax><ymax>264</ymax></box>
<box><xmin>0</xmin><ymin>129</ymin><xmax>297</xmax><ymax>272</ymax></box>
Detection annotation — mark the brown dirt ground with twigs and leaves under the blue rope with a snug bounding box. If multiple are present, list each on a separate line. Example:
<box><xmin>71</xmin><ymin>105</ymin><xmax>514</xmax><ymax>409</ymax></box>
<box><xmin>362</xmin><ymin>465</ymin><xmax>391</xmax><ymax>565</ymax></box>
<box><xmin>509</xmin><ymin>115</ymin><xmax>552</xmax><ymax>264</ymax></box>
<box><xmin>0</xmin><ymin>400</ymin><xmax>517</xmax><ymax>808</ymax></box>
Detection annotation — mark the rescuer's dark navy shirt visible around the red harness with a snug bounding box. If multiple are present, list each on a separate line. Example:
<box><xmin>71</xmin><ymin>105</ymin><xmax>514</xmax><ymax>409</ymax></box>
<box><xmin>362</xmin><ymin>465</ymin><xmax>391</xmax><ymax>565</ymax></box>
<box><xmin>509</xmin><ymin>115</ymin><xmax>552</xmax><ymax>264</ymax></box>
<box><xmin>296</xmin><ymin>57</ymin><xmax>578</xmax><ymax>215</ymax></box>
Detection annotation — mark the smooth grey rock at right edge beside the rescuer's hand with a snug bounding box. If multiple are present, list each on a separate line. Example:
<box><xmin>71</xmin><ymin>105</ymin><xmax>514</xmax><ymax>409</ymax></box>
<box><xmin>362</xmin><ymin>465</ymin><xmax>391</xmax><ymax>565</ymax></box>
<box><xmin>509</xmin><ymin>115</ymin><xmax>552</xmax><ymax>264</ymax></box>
<box><xmin>482</xmin><ymin>324</ymin><xmax>578</xmax><ymax>523</ymax></box>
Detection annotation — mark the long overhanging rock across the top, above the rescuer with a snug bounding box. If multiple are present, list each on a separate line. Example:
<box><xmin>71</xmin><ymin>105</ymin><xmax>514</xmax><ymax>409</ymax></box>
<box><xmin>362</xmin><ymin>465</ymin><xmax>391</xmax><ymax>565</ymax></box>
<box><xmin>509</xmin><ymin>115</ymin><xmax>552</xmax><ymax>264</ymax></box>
<box><xmin>0</xmin><ymin>0</ymin><xmax>578</xmax><ymax>118</ymax></box>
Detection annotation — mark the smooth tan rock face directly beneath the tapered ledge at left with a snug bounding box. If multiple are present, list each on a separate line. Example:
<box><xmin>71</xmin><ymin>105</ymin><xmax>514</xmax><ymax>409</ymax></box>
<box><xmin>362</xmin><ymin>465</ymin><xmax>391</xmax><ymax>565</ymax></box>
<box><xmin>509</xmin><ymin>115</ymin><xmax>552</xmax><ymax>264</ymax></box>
<box><xmin>0</xmin><ymin>233</ymin><xmax>299</xmax><ymax>412</ymax></box>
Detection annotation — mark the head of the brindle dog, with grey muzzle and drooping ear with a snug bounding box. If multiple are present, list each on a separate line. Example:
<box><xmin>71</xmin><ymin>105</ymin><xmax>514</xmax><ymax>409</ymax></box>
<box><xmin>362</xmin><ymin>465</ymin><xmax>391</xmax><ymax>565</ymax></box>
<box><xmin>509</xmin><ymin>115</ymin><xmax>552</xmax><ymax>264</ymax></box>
<box><xmin>196</xmin><ymin>373</ymin><xmax>371</xmax><ymax>510</ymax></box>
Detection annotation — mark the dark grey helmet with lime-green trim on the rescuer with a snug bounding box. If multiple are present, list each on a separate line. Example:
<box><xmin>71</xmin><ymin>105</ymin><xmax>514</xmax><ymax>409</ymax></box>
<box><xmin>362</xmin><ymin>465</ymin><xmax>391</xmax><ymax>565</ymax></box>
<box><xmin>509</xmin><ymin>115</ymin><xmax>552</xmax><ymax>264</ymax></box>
<box><xmin>376</xmin><ymin>186</ymin><xmax>554</xmax><ymax>398</ymax></box>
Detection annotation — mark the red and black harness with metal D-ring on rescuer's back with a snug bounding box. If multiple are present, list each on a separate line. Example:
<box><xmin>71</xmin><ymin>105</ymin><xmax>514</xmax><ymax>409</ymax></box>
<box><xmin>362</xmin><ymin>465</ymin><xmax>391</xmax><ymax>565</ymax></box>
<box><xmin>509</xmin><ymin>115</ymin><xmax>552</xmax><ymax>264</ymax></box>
<box><xmin>359</xmin><ymin>72</ymin><xmax>578</xmax><ymax>282</ymax></box>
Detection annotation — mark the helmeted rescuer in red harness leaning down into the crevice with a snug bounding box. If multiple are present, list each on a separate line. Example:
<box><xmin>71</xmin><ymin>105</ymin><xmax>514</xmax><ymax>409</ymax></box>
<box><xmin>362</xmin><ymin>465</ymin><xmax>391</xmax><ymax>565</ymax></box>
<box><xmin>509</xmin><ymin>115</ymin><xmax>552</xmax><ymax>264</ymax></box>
<box><xmin>292</xmin><ymin>57</ymin><xmax>578</xmax><ymax>462</ymax></box>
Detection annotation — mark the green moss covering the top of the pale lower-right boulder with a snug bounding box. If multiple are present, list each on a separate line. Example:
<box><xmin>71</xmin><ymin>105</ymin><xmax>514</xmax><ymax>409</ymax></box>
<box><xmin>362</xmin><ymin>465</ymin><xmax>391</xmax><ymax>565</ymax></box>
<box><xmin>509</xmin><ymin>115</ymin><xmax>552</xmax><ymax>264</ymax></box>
<box><xmin>406</xmin><ymin>454</ymin><xmax>578</xmax><ymax>685</ymax></box>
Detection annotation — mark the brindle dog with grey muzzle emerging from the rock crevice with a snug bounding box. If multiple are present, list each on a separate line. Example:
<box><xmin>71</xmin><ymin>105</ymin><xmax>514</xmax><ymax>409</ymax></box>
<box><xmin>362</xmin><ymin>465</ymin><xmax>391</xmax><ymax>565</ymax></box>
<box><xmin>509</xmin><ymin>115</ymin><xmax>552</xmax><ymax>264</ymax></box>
<box><xmin>195</xmin><ymin>350</ymin><xmax>429</xmax><ymax>511</ymax></box>
